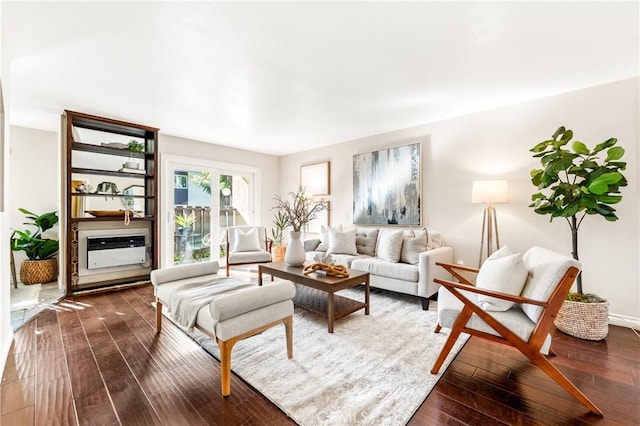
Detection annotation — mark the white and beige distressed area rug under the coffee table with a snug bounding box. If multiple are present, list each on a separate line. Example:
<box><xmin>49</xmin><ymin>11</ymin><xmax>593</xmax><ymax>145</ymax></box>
<box><xmin>168</xmin><ymin>288</ymin><xmax>466</xmax><ymax>426</ymax></box>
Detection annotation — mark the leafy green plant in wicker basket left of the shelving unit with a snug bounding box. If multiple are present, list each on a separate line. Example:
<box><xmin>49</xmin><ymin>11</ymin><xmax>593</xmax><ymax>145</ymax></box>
<box><xmin>11</xmin><ymin>208</ymin><xmax>59</xmax><ymax>284</ymax></box>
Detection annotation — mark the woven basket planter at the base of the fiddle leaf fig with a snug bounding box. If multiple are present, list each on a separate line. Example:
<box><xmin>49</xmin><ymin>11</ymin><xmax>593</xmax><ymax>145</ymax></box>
<box><xmin>554</xmin><ymin>300</ymin><xmax>609</xmax><ymax>340</ymax></box>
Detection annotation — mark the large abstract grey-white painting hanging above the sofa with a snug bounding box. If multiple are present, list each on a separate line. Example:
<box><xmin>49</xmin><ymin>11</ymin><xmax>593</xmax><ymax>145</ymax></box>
<box><xmin>353</xmin><ymin>143</ymin><xmax>420</xmax><ymax>225</ymax></box>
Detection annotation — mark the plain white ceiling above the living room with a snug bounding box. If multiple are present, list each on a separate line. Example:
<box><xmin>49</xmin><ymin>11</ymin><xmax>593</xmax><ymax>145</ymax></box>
<box><xmin>1</xmin><ymin>1</ymin><xmax>640</xmax><ymax>155</ymax></box>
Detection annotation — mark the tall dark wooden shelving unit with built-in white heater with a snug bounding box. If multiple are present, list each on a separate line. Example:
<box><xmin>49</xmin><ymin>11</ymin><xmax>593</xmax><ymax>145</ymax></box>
<box><xmin>60</xmin><ymin>110</ymin><xmax>158</xmax><ymax>295</ymax></box>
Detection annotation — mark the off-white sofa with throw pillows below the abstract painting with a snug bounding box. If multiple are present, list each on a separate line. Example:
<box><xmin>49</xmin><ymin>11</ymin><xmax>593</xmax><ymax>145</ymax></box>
<box><xmin>304</xmin><ymin>226</ymin><xmax>453</xmax><ymax>310</ymax></box>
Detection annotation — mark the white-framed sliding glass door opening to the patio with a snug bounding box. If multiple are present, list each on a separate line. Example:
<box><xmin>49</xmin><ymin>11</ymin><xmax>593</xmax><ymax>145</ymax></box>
<box><xmin>160</xmin><ymin>155</ymin><xmax>260</xmax><ymax>267</ymax></box>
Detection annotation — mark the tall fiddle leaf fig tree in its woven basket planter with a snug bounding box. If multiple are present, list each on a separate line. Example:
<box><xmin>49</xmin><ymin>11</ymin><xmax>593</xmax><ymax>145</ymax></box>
<box><xmin>529</xmin><ymin>127</ymin><xmax>627</xmax><ymax>340</ymax></box>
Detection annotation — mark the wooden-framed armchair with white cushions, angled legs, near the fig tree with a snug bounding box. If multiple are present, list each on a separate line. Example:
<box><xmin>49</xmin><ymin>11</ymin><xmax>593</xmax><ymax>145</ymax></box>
<box><xmin>431</xmin><ymin>247</ymin><xmax>602</xmax><ymax>415</ymax></box>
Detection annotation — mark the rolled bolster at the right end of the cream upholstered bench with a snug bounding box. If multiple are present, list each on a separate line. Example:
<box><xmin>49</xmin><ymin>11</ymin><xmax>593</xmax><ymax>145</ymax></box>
<box><xmin>209</xmin><ymin>281</ymin><xmax>296</xmax><ymax>321</ymax></box>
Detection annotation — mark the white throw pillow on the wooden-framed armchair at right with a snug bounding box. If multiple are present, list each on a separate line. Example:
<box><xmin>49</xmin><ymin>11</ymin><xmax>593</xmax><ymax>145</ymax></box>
<box><xmin>476</xmin><ymin>246</ymin><xmax>528</xmax><ymax>311</ymax></box>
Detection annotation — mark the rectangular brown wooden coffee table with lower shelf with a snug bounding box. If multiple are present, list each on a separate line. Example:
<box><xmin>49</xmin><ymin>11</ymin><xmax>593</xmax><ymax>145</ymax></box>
<box><xmin>258</xmin><ymin>262</ymin><xmax>369</xmax><ymax>333</ymax></box>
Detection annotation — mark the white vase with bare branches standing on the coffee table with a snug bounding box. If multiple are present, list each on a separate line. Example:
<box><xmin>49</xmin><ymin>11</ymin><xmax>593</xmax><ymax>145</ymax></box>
<box><xmin>274</xmin><ymin>187</ymin><xmax>327</xmax><ymax>266</ymax></box>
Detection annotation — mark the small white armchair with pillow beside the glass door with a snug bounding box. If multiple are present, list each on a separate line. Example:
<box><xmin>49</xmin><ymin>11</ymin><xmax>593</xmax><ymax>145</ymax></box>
<box><xmin>226</xmin><ymin>226</ymin><xmax>271</xmax><ymax>276</ymax></box>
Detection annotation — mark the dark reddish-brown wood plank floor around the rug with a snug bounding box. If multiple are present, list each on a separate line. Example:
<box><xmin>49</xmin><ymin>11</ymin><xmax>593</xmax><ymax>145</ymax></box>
<box><xmin>0</xmin><ymin>286</ymin><xmax>640</xmax><ymax>426</ymax></box>
